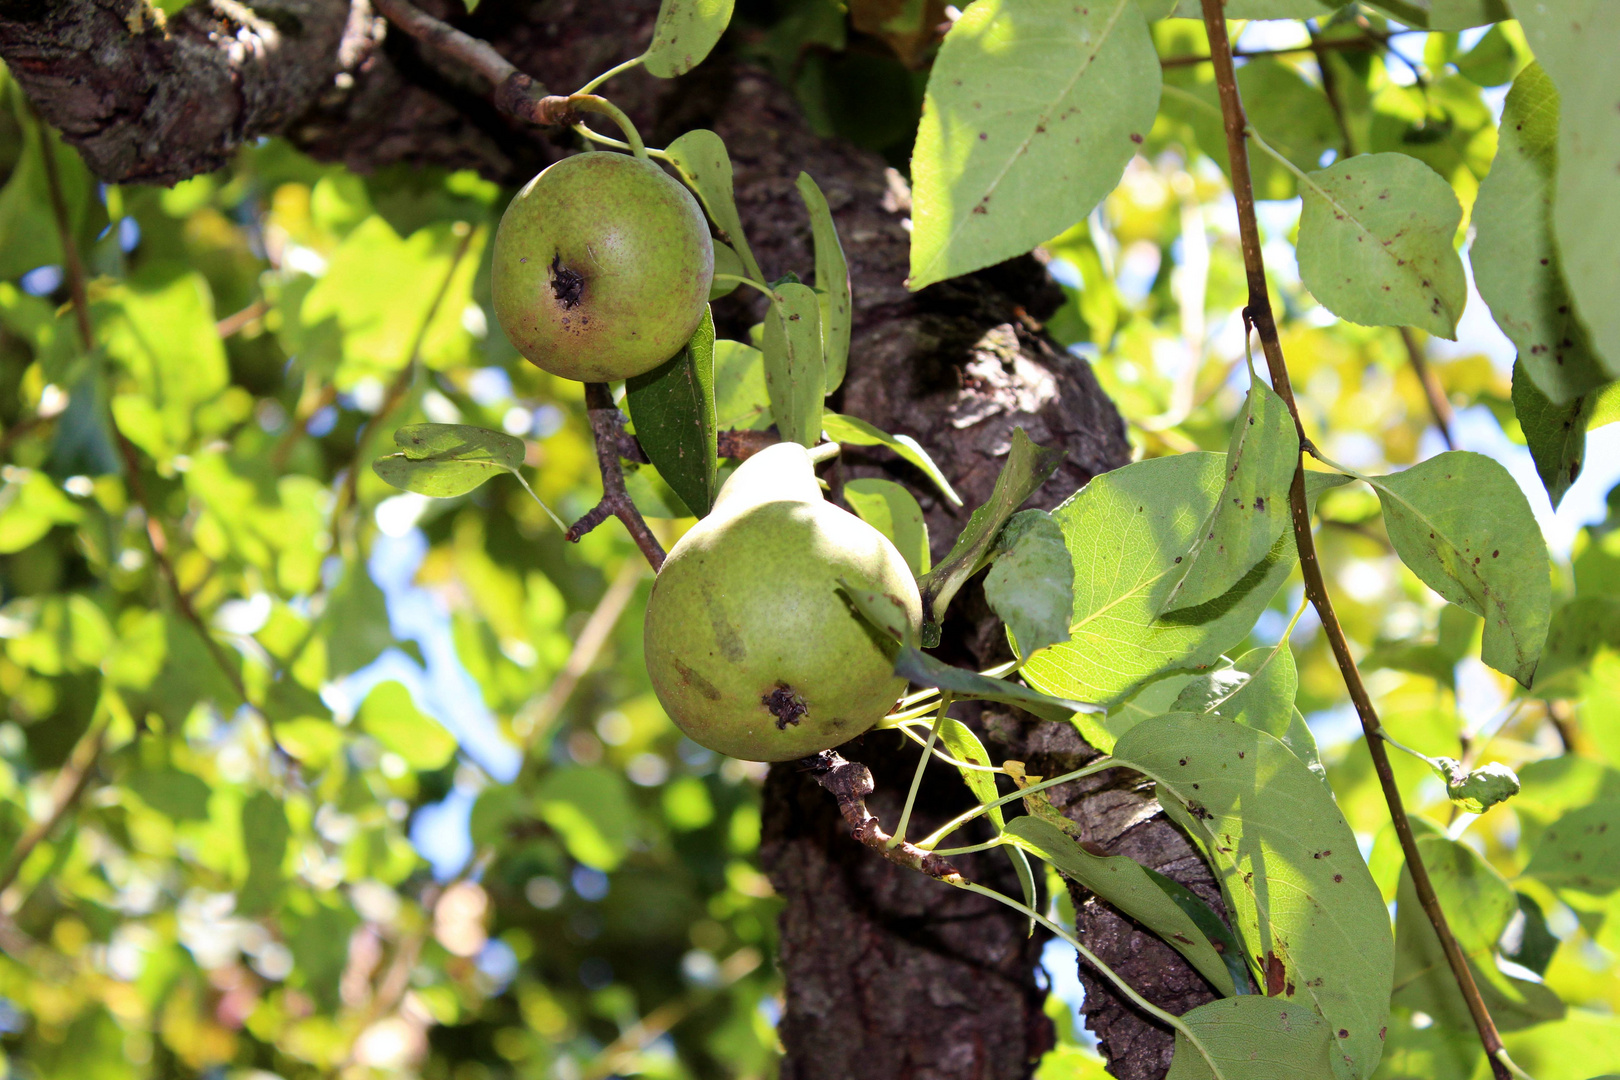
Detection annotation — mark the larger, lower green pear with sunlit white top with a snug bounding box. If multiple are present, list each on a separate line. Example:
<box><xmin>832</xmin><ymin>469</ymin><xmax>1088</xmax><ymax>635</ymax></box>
<box><xmin>645</xmin><ymin>442</ymin><xmax>922</xmax><ymax>761</ymax></box>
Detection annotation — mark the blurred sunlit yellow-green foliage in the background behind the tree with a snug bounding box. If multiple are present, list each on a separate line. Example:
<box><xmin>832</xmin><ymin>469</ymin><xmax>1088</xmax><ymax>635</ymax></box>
<box><xmin>0</xmin><ymin>0</ymin><xmax>1620</xmax><ymax>1080</ymax></box>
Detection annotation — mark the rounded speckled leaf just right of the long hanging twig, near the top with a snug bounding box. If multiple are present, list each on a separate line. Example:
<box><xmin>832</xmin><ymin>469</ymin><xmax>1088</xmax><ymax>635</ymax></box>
<box><xmin>1298</xmin><ymin>154</ymin><xmax>1468</xmax><ymax>338</ymax></box>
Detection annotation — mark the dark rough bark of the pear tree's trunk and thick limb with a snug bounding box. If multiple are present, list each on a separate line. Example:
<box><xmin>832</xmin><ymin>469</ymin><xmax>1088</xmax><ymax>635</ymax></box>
<box><xmin>0</xmin><ymin>0</ymin><xmax>1220</xmax><ymax>1080</ymax></box>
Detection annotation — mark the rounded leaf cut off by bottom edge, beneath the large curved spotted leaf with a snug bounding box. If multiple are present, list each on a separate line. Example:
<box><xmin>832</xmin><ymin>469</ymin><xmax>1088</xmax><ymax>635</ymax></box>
<box><xmin>1165</xmin><ymin>994</ymin><xmax>1334</xmax><ymax>1080</ymax></box>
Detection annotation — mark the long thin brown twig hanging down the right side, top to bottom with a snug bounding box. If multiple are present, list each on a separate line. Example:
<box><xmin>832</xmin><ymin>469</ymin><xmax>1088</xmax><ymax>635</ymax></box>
<box><xmin>1202</xmin><ymin>0</ymin><xmax>1511</xmax><ymax>1080</ymax></box>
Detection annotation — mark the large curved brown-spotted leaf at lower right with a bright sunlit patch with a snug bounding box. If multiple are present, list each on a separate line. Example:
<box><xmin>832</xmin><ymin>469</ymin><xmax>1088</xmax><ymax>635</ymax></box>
<box><xmin>1115</xmin><ymin>712</ymin><xmax>1395</xmax><ymax>1077</ymax></box>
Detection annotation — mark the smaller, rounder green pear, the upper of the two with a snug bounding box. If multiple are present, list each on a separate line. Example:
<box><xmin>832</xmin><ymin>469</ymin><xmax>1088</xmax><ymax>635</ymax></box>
<box><xmin>494</xmin><ymin>152</ymin><xmax>714</xmax><ymax>382</ymax></box>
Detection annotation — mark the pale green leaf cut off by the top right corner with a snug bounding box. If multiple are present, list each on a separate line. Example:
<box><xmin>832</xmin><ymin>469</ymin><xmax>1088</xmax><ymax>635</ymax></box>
<box><xmin>1515</xmin><ymin>0</ymin><xmax>1620</xmax><ymax>377</ymax></box>
